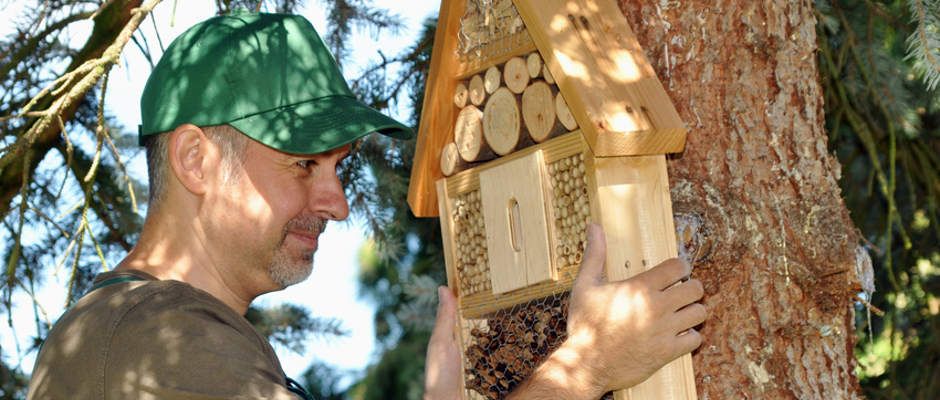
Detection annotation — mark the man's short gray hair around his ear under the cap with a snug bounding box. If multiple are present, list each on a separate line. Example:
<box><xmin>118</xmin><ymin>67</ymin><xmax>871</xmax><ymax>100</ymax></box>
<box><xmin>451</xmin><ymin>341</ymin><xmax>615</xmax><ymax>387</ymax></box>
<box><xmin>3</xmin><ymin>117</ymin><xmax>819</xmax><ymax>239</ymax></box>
<box><xmin>143</xmin><ymin>124</ymin><xmax>249</xmax><ymax>209</ymax></box>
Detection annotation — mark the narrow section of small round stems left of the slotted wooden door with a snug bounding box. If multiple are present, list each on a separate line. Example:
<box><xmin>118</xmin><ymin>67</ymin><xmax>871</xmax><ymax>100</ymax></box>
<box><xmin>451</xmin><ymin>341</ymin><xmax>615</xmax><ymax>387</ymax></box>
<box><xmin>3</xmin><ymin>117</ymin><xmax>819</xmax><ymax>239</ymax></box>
<box><xmin>451</xmin><ymin>190</ymin><xmax>491</xmax><ymax>296</ymax></box>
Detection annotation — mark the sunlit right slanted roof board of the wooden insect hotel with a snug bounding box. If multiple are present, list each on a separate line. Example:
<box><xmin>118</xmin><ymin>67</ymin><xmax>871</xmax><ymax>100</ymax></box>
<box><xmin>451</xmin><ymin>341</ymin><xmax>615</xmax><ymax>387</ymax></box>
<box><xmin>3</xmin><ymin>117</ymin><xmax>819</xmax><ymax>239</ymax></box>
<box><xmin>514</xmin><ymin>0</ymin><xmax>686</xmax><ymax>157</ymax></box>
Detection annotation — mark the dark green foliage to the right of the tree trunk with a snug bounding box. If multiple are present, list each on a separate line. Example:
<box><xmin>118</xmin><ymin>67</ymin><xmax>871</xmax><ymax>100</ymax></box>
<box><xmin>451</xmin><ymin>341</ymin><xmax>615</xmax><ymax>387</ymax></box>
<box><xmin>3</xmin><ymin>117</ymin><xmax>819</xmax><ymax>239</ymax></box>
<box><xmin>817</xmin><ymin>0</ymin><xmax>940</xmax><ymax>399</ymax></box>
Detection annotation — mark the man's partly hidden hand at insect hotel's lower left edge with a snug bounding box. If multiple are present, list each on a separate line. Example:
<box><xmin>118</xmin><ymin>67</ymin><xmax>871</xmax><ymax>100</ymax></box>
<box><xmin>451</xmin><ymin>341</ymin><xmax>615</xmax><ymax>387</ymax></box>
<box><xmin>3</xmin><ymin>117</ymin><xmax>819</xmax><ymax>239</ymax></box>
<box><xmin>424</xmin><ymin>286</ymin><xmax>463</xmax><ymax>400</ymax></box>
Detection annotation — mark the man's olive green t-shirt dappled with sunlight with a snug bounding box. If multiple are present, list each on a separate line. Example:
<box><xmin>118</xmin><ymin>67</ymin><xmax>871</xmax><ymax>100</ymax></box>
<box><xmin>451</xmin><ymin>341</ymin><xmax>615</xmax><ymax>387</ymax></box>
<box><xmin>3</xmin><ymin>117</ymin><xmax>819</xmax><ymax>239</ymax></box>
<box><xmin>27</xmin><ymin>270</ymin><xmax>298</xmax><ymax>400</ymax></box>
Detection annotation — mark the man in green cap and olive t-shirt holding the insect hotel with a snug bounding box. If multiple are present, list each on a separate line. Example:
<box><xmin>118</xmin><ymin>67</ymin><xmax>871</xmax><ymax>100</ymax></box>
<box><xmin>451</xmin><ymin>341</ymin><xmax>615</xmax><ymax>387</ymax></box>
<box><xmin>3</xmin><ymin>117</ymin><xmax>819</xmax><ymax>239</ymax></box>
<box><xmin>29</xmin><ymin>10</ymin><xmax>705</xmax><ymax>399</ymax></box>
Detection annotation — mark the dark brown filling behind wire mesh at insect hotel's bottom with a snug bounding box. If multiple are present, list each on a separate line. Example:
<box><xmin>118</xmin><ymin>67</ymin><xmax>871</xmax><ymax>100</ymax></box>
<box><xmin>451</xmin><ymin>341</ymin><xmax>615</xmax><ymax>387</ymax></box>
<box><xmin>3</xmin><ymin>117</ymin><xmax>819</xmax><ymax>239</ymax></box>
<box><xmin>464</xmin><ymin>292</ymin><xmax>569</xmax><ymax>399</ymax></box>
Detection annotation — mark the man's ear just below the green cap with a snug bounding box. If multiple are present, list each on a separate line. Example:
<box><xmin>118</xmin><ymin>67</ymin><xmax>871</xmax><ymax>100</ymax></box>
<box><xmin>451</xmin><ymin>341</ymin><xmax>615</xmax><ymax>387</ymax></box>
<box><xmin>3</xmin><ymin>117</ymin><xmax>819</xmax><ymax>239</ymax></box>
<box><xmin>167</xmin><ymin>124</ymin><xmax>218</xmax><ymax>195</ymax></box>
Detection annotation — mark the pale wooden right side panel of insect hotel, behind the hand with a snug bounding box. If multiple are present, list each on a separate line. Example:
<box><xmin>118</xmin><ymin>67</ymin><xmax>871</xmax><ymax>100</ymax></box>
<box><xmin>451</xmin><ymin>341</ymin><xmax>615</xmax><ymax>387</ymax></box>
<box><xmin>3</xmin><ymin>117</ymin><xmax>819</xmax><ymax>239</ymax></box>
<box><xmin>595</xmin><ymin>155</ymin><xmax>697</xmax><ymax>400</ymax></box>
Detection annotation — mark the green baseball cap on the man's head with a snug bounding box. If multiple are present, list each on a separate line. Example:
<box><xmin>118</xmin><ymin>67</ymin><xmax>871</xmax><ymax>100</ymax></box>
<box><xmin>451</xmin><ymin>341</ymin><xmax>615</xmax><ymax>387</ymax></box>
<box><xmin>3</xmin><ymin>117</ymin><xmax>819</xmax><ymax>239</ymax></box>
<box><xmin>140</xmin><ymin>12</ymin><xmax>414</xmax><ymax>154</ymax></box>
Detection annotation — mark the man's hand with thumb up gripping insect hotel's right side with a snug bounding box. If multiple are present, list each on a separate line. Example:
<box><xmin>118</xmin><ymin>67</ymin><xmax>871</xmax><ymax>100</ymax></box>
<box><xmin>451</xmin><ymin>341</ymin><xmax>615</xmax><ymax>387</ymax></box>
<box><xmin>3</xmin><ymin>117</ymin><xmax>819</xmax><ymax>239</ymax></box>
<box><xmin>565</xmin><ymin>224</ymin><xmax>706</xmax><ymax>392</ymax></box>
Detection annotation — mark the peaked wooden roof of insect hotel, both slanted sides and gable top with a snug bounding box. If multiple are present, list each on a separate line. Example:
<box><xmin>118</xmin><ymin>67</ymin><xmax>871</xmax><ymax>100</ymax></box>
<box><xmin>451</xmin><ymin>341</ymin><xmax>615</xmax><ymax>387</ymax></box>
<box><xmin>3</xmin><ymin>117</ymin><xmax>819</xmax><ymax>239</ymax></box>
<box><xmin>408</xmin><ymin>0</ymin><xmax>686</xmax><ymax>217</ymax></box>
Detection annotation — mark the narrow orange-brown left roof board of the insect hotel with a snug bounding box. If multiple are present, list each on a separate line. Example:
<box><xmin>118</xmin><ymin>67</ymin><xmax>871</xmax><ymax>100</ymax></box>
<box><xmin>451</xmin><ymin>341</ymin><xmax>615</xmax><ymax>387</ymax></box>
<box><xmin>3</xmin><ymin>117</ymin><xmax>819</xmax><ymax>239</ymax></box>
<box><xmin>408</xmin><ymin>0</ymin><xmax>466</xmax><ymax>217</ymax></box>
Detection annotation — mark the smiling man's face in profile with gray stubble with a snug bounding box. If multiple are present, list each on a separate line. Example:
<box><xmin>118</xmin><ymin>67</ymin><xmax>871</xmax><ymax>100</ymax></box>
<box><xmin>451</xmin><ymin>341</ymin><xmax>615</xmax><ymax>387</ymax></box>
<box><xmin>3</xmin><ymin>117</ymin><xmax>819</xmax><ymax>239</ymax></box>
<box><xmin>207</xmin><ymin>140</ymin><xmax>349</xmax><ymax>291</ymax></box>
